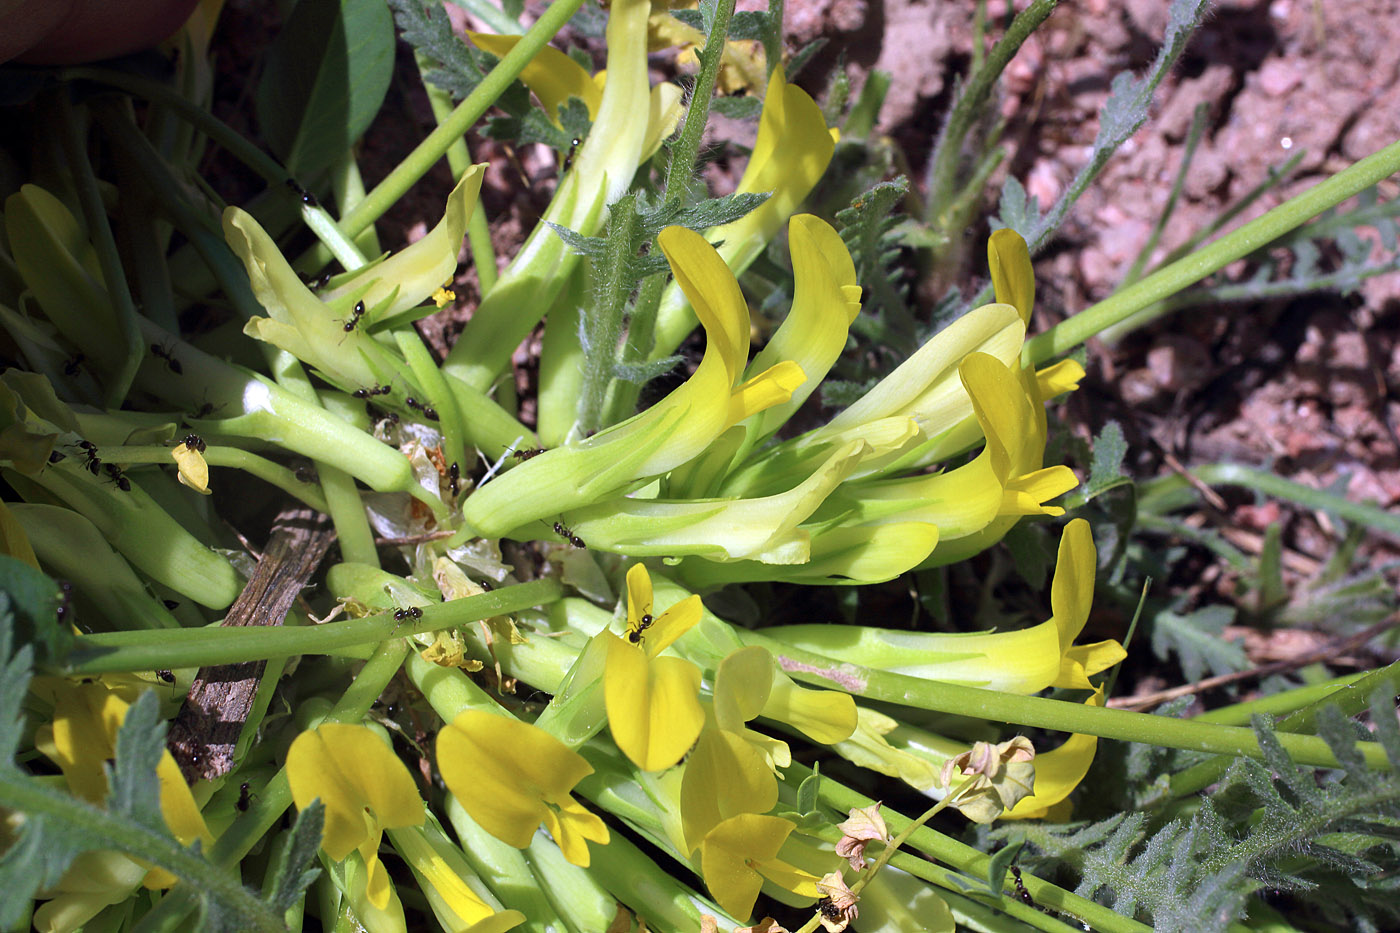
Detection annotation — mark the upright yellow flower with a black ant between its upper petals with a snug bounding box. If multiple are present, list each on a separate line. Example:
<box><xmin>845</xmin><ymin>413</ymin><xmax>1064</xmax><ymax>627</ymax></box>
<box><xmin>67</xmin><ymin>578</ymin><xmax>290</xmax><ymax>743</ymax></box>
<box><xmin>598</xmin><ymin>563</ymin><xmax>704</xmax><ymax>770</ymax></box>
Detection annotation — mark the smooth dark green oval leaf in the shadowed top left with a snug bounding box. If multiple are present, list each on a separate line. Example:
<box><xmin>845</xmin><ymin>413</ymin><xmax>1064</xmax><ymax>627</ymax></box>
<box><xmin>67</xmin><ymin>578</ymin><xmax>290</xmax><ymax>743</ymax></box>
<box><xmin>258</xmin><ymin>0</ymin><xmax>393</xmax><ymax>177</ymax></box>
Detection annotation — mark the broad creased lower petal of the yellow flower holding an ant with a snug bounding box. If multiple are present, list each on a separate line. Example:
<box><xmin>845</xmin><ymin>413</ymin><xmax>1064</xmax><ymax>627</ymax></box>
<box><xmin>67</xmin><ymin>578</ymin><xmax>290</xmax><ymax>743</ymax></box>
<box><xmin>603</xmin><ymin>635</ymin><xmax>704</xmax><ymax>770</ymax></box>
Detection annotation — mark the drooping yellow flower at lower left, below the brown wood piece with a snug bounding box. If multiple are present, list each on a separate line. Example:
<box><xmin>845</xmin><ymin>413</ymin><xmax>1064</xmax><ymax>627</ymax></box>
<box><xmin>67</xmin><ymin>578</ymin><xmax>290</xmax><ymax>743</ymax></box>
<box><xmin>287</xmin><ymin>723</ymin><xmax>423</xmax><ymax>909</ymax></box>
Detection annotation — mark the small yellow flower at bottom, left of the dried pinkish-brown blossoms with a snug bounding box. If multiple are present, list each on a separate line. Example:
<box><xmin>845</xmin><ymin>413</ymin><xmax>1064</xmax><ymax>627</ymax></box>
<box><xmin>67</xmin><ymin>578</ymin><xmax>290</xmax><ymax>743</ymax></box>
<box><xmin>700</xmin><ymin>813</ymin><xmax>819</xmax><ymax>916</ymax></box>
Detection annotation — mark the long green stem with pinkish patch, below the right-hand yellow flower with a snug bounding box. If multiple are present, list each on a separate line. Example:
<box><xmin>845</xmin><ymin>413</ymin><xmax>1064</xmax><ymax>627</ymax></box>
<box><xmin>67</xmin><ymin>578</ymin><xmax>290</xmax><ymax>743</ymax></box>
<box><xmin>736</xmin><ymin>629</ymin><xmax>1392</xmax><ymax>769</ymax></box>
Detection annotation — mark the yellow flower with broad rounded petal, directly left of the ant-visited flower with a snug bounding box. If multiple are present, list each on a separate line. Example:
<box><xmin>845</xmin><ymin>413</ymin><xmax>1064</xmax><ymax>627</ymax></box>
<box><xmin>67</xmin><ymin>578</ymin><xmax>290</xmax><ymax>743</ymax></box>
<box><xmin>437</xmin><ymin>709</ymin><xmax>608</xmax><ymax>867</ymax></box>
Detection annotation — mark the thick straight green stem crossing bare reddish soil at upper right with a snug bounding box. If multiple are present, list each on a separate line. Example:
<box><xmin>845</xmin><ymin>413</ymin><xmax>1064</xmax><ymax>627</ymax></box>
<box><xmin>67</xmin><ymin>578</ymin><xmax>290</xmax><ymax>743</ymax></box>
<box><xmin>1022</xmin><ymin>141</ymin><xmax>1400</xmax><ymax>364</ymax></box>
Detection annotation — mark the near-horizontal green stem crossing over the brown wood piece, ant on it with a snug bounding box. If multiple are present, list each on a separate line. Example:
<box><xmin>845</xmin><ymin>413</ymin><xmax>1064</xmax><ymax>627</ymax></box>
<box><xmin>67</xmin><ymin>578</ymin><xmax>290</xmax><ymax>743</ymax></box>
<box><xmin>71</xmin><ymin>580</ymin><xmax>563</xmax><ymax>675</ymax></box>
